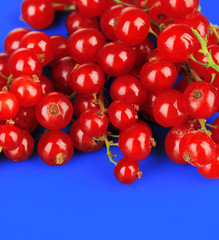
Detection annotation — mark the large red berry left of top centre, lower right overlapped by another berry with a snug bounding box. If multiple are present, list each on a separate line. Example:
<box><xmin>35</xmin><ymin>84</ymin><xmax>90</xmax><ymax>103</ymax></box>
<box><xmin>68</xmin><ymin>28</ymin><xmax>106</xmax><ymax>63</ymax></box>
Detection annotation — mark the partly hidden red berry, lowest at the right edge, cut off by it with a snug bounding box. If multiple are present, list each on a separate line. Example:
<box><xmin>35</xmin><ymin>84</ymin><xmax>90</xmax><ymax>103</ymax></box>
<box><xmin>197</xmin><ymin>145</ymin><xmax>219</xmax><ymax>179</ymax></box>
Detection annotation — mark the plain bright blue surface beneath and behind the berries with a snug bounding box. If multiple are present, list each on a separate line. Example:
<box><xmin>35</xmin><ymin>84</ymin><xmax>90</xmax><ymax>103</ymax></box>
<box><xmin>0</xmin><ymin>0</ymin><xmax>219</xmax><ymax>240</ymax></box>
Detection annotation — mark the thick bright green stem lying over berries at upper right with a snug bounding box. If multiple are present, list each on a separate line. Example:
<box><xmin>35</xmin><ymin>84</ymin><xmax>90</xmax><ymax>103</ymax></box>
<box><xmin>190</xmin><ymin>29</ymin><xmax>219</xmax><ymax>72</ymax></box>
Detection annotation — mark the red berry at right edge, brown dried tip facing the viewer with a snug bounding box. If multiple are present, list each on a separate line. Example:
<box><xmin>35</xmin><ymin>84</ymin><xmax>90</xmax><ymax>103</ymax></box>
<box><xmin>183</xmin><ymin>81</ymin><xmax>218</xmax><ymax>119</ymax></box>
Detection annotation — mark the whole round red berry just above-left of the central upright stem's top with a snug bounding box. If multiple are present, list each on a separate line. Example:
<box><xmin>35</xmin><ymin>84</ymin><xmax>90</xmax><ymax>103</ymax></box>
<box><xmin>70</xmin><ymin>63</ymin><xmax>105</xmax><ymax>95</ymax></box>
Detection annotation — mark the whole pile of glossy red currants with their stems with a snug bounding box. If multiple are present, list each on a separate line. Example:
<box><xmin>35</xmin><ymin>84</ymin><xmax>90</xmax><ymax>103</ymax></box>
<box><xmin>0</xmin><ymin>0</ymin><xmax>219</xmax><ymax>184</ymax></box>
